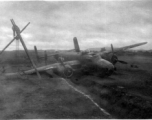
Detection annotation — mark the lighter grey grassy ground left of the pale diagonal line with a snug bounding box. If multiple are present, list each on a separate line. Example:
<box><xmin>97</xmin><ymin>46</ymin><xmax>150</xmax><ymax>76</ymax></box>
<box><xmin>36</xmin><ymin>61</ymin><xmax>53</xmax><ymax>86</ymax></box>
<box><xmin>0</xmin><ymin>76</ymin><xmax>109</xmax><ymax>119</ymax></box>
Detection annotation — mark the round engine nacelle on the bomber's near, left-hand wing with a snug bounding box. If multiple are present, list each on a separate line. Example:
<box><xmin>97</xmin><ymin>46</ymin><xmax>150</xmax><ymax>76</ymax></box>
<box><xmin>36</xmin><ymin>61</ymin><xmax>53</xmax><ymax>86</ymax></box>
<box><xmin>53</xmin><ymin>65</ymin><xmax>73</xmax><ymax>78</ymax></box>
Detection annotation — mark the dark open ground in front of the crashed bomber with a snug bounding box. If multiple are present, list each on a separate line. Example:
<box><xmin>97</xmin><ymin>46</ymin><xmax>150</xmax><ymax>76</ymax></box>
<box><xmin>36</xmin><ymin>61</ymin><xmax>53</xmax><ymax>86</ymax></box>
<box><xmin>0</xmin><ymin>52</ymin><xmax>152</xmax><ymax>119</ymax></box>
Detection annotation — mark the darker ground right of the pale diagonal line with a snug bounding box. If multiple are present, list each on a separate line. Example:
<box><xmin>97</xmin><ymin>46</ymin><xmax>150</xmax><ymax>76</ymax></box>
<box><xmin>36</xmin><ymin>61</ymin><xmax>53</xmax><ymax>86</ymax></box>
<box><xmin>68</xmin><ymin>55</ymin><xmax>152</xmax><ymax>119</ymax></box>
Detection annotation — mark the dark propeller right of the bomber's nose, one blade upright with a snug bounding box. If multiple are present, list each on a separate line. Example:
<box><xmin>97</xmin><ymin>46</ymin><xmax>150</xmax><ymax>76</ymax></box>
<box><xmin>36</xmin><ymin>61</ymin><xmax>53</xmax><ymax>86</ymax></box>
<box><xmin>111</xmin><ymin>44</ymin><xmax>128</xmax><ymax>64</ymax></box>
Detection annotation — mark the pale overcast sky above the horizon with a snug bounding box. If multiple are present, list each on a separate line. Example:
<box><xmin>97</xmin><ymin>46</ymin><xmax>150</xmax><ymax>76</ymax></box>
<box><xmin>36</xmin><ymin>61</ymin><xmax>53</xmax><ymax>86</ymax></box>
<box><xmin>0</xmin><ymin>0</ymin><xmax>152</xmax><ymax>50</ymax></box>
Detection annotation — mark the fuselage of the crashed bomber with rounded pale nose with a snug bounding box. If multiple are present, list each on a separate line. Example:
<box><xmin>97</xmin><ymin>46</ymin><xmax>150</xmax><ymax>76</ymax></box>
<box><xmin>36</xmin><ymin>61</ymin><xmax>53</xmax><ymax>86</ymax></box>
<box><xmin>55</xmin><ymin>52</ymin><xmax>114</xmax><ymax>75</ymax></box>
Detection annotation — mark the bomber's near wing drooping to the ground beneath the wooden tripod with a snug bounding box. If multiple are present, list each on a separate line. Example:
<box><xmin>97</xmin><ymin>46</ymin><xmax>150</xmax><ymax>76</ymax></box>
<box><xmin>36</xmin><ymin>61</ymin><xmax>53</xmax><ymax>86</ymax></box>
<box><xmin>5</xmin><ymin>60</ymin><xmax>80</xmax><ymax>76</ymax></box>
